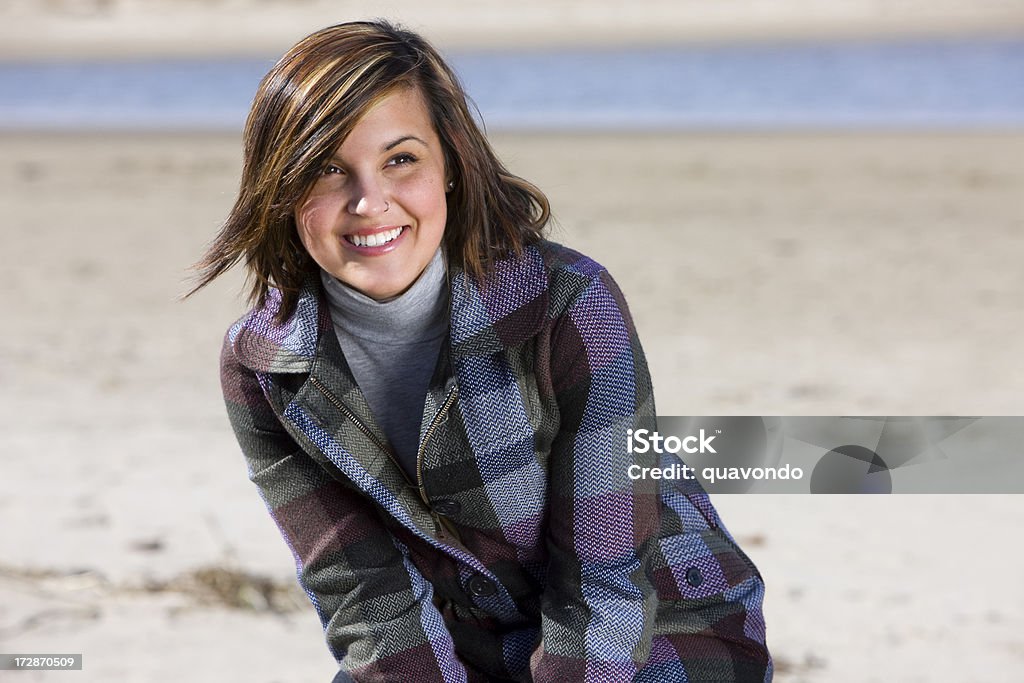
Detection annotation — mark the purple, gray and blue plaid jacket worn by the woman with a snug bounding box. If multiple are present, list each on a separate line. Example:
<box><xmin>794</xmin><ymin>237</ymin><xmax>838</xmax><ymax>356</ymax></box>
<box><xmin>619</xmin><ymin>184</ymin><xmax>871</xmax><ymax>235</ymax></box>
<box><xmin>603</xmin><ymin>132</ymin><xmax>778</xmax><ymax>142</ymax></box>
<box><xmin>221</xmin><ymin>243</ymin><xmax>771</xmax><ymax>683</ymax></box>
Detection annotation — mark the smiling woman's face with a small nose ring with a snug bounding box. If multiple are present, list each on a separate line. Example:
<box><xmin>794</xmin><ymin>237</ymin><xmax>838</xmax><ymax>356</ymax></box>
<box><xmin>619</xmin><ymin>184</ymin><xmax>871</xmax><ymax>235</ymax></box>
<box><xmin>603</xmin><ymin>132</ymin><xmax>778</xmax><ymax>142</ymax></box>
<box><xmin>295</xmin><ymin>88</ymin><xmax>447</xmax><ymax>301</ymax></box>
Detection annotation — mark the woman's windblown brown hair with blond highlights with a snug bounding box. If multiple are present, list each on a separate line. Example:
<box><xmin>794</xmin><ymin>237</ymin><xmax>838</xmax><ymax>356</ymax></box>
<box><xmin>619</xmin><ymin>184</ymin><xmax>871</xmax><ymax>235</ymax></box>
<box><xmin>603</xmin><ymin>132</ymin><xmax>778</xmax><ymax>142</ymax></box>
<box><xmin>189</xmin><ymin>20</ymin><xmax>550</xmax><ymax>322</ymax></box>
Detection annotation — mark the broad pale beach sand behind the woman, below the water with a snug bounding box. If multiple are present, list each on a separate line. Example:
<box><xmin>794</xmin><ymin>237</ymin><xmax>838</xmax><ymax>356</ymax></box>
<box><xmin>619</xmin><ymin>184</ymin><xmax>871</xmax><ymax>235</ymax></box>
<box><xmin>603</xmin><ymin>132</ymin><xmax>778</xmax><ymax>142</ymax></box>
<box><xmin>0</xmin><ymin>133</ymin><xmax>1024</xmax><ymax>683</ymax></box>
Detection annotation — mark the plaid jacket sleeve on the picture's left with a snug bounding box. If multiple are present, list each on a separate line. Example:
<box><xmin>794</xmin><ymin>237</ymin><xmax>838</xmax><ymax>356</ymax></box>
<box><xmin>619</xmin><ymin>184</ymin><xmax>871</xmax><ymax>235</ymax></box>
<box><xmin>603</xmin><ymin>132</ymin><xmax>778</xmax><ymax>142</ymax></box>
<box><xmin>221</xmin><ymin>333</ymin><xmax>467</xmax><ymax>683</ymax></box>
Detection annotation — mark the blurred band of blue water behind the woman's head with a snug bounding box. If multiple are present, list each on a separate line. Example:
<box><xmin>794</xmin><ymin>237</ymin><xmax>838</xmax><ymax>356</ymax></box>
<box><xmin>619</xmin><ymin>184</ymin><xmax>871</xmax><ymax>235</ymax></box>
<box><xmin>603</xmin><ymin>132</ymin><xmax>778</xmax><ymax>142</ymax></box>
<box><xmin>0</xmin><ymin>39</ymin><xmax>1024</xmax><ymax>130</ymax></box>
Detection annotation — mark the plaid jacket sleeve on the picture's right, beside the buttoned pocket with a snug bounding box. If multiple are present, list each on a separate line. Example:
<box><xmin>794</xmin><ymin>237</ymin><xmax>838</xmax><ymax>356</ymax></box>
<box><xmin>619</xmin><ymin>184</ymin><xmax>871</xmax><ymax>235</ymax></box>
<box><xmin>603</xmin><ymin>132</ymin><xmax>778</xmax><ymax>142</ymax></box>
<box><xmin>530</xmin><ymin>271</ymin><xmax>658</xmax><ymax>683</ymax></box>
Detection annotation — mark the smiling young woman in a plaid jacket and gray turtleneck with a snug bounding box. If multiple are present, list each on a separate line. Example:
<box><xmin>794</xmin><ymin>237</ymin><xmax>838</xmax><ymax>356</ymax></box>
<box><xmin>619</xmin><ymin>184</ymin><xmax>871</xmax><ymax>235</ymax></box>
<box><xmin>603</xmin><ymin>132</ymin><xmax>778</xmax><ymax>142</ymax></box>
<box><xmin>190</xmin><ymin>23</ymin><xmax>771</xmax><ymax>683</ymax></box>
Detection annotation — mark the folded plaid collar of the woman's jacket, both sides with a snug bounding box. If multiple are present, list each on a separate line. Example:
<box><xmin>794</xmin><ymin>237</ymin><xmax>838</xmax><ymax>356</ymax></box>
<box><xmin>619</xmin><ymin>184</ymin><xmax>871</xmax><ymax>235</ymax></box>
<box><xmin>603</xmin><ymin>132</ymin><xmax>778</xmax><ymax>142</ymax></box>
<box><xmin>228</xmin><ymin>246</ymin><xmax>549</xmax><ymax>373</ymax></box>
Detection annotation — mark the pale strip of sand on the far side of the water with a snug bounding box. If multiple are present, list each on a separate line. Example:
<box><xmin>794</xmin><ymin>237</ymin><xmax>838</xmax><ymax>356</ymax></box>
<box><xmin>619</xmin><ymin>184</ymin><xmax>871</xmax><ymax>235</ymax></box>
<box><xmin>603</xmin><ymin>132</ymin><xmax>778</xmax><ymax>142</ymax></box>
<box><xmin>6</xmin><ymin>0</ymin><xmax>1024</xmax><ymax>59</ymax></box>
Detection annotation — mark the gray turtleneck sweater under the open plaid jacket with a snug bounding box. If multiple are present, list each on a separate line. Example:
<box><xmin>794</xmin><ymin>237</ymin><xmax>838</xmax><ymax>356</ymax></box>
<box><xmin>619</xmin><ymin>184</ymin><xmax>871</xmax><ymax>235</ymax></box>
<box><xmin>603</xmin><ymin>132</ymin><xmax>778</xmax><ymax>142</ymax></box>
<box><xmin>321</xmin><ymin>249</ymin><xmax>449</xmax><ymax>481</ymax></box>
